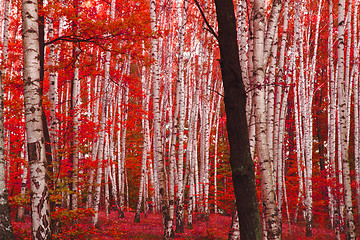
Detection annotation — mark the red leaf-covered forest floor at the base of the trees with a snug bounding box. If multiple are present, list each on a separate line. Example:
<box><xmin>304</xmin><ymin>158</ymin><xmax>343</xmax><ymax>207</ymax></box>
<box><xmin>13</xmin><ymin>212</ymin><xmax>344</xmax><ymax>240</ymax></box>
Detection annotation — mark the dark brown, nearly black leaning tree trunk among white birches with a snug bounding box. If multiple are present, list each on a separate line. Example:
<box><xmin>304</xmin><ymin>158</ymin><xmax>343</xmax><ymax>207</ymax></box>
<box><xmin>215</xmin><ymin>0</ymin><xmax>262</xmax><ymax>240</ymax></box>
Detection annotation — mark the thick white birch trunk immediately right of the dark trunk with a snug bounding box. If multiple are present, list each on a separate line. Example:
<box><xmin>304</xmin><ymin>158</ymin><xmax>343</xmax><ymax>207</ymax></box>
<box><xmin>252</xmin><ymin>0</ymin><xmax>281</xmax><ymax>239</ymax></box>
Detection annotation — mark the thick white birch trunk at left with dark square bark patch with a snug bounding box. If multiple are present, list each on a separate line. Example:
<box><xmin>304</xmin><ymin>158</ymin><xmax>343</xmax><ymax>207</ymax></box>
<box><xmin>22</xmin><ymin>0</ymin><xmax>51</xmax><ymax>239</ymax></box>
